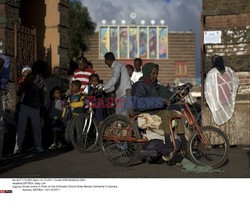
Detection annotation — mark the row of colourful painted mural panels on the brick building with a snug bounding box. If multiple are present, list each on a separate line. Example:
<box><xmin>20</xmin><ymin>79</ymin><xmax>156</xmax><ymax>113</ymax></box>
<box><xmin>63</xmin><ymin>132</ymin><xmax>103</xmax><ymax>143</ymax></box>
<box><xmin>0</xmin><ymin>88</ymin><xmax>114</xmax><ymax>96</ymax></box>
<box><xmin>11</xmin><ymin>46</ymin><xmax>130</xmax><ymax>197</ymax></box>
<box><xmin>100</xmin><ymin>25</ymin><xmax>168</xmax><ymax>59</ymax></box>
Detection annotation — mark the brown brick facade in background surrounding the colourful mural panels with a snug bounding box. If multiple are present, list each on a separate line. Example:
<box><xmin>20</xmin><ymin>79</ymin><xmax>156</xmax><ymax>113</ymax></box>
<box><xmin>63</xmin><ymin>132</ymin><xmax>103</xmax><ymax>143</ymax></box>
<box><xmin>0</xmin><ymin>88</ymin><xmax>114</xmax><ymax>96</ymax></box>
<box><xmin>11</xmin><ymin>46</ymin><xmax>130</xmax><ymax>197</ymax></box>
<box><xmin>84</xmin><ymin>32</ymin><xmax>196</xmax><ymax>85</ymax></box>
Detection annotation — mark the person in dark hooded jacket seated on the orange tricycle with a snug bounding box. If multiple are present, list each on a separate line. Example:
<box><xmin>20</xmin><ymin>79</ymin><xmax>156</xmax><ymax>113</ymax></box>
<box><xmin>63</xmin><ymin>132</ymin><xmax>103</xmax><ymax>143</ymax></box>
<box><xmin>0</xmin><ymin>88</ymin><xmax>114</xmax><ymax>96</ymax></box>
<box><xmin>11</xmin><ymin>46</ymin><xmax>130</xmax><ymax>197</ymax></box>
<box><xmin>132</xmin><ymin>63</ymin><xmax>184</xmax><ymax>162</ymax></box>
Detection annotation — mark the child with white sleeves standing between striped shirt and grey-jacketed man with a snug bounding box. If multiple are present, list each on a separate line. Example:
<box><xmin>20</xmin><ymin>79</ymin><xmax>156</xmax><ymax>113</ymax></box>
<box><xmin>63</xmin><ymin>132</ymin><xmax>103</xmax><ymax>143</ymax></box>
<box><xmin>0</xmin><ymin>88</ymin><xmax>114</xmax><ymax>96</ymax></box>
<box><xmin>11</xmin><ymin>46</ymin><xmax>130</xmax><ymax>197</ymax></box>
<box><xmin>83</xmin><ymin>74</ymin><xmax>105</xmax><ymax>122</ymax></box>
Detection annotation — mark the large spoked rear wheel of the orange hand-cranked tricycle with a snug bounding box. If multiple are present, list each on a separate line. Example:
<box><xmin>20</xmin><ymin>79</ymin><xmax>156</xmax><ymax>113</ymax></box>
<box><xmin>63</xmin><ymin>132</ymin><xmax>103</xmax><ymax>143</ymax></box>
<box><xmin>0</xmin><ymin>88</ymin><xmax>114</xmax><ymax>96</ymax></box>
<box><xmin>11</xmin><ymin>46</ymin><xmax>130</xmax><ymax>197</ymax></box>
<box><xmin>99</xmin><ymin>114</ymin><xmax>141</xmax><ymax>166</ymax></box>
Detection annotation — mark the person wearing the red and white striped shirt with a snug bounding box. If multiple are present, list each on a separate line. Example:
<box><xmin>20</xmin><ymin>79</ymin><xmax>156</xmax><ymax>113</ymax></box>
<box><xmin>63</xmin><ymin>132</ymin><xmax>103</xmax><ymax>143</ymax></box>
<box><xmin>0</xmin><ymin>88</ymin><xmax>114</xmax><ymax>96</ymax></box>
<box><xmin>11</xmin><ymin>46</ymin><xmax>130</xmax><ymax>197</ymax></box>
<box><xmin>72</xmin><ymin>57</ymin><xmax>95</xmax><ymax>92</ymax></box>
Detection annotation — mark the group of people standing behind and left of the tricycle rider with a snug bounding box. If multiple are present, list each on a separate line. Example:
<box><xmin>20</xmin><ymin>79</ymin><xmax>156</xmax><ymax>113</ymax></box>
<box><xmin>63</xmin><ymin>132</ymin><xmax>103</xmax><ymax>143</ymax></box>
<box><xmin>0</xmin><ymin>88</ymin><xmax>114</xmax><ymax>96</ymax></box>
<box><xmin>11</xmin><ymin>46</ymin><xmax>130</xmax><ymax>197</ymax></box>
<box><xmin>0</xmin><ymin>52</ymin><xmax>164</xmax><ymax>158</ymax></box>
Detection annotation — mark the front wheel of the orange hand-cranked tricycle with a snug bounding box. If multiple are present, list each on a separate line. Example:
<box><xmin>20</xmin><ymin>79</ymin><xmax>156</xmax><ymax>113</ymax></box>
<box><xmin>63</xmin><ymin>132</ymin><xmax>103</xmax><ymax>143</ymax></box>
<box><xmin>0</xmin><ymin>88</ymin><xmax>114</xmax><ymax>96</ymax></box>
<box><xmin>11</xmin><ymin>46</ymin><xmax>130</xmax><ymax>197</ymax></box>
<box><xmin>187</xmin><ymin>126</ymin><xmax>230</xmax><ymax>168</ymax></box>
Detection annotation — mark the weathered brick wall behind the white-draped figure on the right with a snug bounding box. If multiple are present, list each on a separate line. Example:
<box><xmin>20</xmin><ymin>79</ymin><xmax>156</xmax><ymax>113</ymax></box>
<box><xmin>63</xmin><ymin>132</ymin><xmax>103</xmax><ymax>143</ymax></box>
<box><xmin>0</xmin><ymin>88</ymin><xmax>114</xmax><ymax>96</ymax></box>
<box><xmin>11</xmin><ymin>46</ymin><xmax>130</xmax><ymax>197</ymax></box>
<box><xmin>201</xmin><ymin>0</ymin><xmax>250</xmax><ymax>145</ymax></box>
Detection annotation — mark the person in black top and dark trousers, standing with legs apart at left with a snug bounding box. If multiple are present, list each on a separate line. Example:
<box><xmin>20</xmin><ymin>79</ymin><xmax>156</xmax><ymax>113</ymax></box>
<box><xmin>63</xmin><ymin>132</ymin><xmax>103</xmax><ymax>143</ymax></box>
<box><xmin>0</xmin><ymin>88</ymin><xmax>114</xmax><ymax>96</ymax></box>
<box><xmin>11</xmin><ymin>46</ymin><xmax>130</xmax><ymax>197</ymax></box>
<box><xmin>14</xmin><ymin>73</ymin><xmax>44</xmax><ymax>154</ymax></box>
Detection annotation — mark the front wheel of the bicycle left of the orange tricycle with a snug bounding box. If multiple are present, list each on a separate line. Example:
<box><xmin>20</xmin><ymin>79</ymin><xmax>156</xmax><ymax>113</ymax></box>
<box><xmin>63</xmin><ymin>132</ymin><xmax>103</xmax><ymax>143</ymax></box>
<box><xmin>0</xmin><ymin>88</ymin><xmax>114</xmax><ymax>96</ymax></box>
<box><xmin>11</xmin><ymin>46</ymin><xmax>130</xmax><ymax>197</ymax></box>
<box><xmin>70</xmin><ymin>113</ymin><xmax>98</xmax><ymax>152</ymax></box>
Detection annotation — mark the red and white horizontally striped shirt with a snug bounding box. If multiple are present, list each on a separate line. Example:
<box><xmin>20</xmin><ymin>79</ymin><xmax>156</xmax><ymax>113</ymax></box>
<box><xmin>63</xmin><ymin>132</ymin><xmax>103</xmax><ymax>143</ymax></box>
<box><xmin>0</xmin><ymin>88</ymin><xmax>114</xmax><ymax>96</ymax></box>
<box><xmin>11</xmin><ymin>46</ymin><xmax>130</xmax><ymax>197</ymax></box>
<box><xmin>72</xmin><ymin>67</ymin><xmax>95</xmax><ymax>92</ymax></box>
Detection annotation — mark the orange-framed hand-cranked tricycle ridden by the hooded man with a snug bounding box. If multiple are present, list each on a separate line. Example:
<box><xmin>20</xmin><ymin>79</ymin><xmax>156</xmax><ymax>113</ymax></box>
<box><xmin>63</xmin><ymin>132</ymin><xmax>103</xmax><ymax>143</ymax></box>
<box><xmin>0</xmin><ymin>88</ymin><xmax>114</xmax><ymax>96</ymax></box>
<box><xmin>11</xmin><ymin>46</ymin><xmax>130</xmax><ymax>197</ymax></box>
<box><xmin>99</xmin><ymin>84</ymin><xmax>230</xmax><ymax>168</ymax></box>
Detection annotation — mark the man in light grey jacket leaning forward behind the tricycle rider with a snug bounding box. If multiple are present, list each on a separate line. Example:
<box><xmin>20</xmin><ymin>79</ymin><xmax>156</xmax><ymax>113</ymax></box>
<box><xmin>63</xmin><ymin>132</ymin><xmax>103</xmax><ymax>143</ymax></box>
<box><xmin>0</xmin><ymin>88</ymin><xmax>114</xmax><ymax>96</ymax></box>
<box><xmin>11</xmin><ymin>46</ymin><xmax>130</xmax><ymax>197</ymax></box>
<box><xmin>104</xmin><ymin>52</ymin><xmax>131</xmax><ymax>115</ymax></box>
